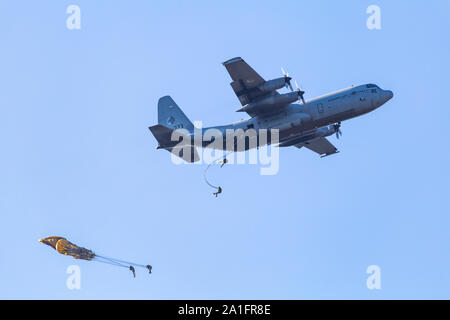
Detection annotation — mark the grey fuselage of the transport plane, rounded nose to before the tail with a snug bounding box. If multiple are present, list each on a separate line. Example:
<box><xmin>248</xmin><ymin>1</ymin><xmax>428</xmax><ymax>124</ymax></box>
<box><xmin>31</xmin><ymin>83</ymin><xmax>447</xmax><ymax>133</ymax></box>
<box><xmin>199</xmin><ymin>84</ymin><xmax>393</xmax><ymax>151</ymax></box>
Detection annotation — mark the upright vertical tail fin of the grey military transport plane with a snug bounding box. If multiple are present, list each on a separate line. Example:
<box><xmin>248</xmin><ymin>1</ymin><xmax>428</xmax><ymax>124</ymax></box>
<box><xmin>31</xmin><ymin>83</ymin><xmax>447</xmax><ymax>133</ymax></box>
<box><xmin>158</xmin><ymin>96</ymin><xmax>194</xmax><ymax>132</ymax></box>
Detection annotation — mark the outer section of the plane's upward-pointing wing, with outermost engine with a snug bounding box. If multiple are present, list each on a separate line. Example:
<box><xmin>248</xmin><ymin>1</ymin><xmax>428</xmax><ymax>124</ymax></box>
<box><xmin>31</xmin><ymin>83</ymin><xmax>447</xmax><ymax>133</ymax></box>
<box><xmin>223</xmin><ymin>57</ymin><xmax>279</xmax><ymax>106</ymax></box>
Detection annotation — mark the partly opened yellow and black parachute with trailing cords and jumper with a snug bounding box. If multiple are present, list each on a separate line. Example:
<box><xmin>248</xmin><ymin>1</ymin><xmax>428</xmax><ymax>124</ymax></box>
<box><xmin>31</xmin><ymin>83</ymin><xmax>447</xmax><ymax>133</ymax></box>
<box><xmin>39</xmin><ymin>236</ymin><xmax>152</xmax><ymax>277</ymax></box>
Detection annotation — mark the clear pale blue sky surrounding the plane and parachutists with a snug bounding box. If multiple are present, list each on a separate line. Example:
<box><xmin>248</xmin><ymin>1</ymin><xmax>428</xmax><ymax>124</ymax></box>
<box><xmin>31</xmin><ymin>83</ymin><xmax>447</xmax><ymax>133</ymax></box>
<box><xmin>0</xmin><ymin>0</ymin><xmax>450</xmax><ymax>299</ymax></box>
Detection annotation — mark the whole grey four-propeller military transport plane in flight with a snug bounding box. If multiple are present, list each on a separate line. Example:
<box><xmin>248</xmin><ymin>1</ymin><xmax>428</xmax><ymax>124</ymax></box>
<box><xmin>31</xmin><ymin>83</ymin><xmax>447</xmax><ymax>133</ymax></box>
<box><xmin>149</xmin><ymin>57</ymin><xmax>393</xmax><ymax>162</ymax></box>
